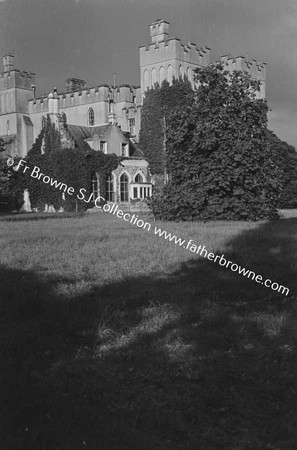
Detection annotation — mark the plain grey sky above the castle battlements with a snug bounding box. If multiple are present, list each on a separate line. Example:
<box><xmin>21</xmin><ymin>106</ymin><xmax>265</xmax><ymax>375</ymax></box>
<box><xmin>0</xmin><ymin>0</ymin><xmax>297</xmax><ymax>147</ymax></box>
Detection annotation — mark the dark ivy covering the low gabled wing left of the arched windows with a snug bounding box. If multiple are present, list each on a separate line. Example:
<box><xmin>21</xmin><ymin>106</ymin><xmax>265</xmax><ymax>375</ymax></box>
<box><xmin>12</xmin><ymin>118</ymin><xmax>118</xmax><ymax>211</ymax></box>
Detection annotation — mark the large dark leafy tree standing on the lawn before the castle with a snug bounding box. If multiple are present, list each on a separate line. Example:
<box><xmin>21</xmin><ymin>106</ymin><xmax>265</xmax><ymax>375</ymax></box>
<box><xmin>152</xmin><ymin>64</ymin><xmax>281</xmax><ymax>220</ymax></box>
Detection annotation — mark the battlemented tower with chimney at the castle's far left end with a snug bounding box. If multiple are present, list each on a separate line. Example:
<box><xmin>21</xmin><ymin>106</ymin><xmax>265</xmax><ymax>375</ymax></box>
<box><xmin>0</xmin><ymin>53</ymin><xmax>35</xmax><ymax>156</ymax></box>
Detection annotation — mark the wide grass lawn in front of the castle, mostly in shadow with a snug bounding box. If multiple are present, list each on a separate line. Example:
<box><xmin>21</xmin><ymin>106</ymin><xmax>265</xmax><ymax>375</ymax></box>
<box><xmin>0</xmin><ymin>213</ymin><xmax>297</xmax><ymax>450</ymax></box>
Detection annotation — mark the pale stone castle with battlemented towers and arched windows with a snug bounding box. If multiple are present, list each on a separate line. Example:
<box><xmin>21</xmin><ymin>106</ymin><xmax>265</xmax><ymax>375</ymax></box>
<box><xmin>0</xmin><ymin>20</ymin><xmax>266</xmax><ymax>206</ymax></box>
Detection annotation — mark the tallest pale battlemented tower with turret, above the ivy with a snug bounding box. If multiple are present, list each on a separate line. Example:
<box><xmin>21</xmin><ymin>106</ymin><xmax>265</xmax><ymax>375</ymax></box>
<box><xmin>139</xmin><ymin>20</ymin><xmax>210</xmax><ymax>96</ymax></box>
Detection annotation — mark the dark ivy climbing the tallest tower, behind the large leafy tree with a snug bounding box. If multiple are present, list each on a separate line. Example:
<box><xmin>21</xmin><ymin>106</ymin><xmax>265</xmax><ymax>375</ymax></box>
<box><xmin>139</xmin><ymin>78</ymin><xmax>194</xmax><ymax>175</ymax></box>
